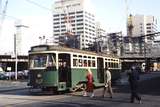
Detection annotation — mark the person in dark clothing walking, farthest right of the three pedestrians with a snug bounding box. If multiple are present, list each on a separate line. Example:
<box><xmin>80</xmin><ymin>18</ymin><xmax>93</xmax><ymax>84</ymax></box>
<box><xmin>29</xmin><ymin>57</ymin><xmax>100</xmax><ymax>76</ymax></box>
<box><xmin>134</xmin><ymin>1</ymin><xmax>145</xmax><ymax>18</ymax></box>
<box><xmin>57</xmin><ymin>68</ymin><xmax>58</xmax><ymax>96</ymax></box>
<box><xmin>128</xmin><ymin>66</ymin><xmax>141</xmax><ymax>103</ymax></box>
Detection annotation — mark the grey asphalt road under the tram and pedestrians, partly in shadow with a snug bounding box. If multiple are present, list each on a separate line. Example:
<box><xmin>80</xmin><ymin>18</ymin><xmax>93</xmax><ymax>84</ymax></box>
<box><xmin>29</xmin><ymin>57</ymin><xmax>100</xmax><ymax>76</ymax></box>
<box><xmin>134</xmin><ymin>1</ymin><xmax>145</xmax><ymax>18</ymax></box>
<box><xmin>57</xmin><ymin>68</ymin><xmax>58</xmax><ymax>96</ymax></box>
<box><xmin>0</xmin><ymin>73</ymin><xmax>160</xmax><ymax>107</ymax></box>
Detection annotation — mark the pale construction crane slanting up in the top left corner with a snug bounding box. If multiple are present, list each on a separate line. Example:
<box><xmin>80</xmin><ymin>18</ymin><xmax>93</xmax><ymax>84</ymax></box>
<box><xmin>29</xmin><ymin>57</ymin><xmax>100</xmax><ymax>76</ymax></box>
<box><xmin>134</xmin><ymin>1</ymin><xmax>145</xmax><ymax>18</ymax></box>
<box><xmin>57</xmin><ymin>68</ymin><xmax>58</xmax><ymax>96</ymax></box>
<box><xmin>0</xmin><ymin>0</ymin><xmax>8</xmax><ymax>35</ymax></box>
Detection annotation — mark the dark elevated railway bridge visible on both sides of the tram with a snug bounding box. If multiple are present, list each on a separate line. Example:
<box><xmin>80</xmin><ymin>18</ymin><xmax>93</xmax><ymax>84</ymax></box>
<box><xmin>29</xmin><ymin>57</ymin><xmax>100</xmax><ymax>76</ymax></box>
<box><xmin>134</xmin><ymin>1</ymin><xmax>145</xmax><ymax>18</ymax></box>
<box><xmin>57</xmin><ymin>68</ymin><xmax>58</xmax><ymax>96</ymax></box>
<box><xmin>0</xmin><ymin>53</ymin><xmax>160</xmax><ymax>71</ymax></box>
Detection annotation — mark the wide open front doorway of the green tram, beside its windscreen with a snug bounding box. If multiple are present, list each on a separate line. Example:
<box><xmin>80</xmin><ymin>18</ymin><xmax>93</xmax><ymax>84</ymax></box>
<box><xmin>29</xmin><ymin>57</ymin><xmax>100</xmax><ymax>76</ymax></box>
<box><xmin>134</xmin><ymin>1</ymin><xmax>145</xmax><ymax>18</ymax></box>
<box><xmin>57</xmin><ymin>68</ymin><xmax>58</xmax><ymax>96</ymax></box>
<box><xmin>58</xmin><ymin>53</ymin><xmax>71</xmax><ymax>86</ymax></box>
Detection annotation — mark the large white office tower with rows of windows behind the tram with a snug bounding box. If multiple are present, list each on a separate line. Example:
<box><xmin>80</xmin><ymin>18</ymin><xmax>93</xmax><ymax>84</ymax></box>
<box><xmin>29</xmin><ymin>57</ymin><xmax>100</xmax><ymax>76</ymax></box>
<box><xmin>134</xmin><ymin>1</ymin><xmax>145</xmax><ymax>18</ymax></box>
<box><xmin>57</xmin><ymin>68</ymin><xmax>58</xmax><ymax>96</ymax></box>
<box><xmin>53</xmin><ymin>0</ymin><xmax>96</xmax><ymax>49</ymax></box>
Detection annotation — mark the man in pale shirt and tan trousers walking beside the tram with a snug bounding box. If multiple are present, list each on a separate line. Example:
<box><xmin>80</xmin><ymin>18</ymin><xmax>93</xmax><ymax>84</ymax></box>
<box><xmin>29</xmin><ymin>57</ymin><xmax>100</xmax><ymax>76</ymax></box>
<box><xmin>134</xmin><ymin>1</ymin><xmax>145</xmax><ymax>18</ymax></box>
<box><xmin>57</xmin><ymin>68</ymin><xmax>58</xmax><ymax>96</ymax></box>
<box><xmin>103</xmin><ymin>67</ymin><xmax>113</xmax><ymax>98</ymax></box>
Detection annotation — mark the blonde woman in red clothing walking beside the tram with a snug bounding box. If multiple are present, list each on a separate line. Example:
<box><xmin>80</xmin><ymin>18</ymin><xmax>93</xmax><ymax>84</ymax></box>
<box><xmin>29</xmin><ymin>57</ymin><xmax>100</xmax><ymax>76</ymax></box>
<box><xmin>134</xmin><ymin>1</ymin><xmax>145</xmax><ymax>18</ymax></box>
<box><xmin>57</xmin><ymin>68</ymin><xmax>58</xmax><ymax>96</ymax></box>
<box><xmin>83</xmin><ymin>68</ymin><xmax>94</xmax><ymax>97</ymax></box>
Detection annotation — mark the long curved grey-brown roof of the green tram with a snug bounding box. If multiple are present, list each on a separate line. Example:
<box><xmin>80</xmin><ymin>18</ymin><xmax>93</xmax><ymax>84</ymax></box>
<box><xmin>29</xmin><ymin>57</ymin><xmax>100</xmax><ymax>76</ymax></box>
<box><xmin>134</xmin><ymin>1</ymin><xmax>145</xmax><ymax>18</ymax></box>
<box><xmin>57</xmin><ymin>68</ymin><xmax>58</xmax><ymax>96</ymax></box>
<box><xmin>31</xmin><ymin>45</ymin><xmax>118</xmax><ymax>58</ymax></box>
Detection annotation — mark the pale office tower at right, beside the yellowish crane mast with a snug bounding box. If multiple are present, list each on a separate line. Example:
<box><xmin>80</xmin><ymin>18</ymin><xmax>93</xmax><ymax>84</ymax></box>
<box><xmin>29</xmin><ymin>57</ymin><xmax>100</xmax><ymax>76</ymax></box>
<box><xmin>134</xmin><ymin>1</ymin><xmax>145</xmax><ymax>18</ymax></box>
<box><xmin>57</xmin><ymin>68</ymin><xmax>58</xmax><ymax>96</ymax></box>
<box><xmin>129</xmin><ymin>15</ymin><xmax>157</xmax><ymax>37</ymax></box>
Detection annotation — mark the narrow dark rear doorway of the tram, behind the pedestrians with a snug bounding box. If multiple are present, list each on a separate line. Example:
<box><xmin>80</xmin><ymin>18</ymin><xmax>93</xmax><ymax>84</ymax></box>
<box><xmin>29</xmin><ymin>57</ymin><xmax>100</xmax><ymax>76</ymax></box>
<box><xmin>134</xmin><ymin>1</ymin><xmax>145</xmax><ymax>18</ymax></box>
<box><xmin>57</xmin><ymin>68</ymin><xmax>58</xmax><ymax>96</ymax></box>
<box><xmin>97</xmin><ymin>58</ymin><xmax>104</xmax><ymax>83</ymax></box>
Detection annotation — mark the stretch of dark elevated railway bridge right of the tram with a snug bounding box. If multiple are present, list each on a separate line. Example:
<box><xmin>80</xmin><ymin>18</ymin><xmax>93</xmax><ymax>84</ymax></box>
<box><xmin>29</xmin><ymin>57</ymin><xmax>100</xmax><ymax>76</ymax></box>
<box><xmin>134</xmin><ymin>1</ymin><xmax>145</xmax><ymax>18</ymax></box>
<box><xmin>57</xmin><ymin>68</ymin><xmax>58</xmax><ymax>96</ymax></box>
<box><xmin>120</xmin><ymin>53</ymin><xmax>160</xmax><ymax>71</ymax></box>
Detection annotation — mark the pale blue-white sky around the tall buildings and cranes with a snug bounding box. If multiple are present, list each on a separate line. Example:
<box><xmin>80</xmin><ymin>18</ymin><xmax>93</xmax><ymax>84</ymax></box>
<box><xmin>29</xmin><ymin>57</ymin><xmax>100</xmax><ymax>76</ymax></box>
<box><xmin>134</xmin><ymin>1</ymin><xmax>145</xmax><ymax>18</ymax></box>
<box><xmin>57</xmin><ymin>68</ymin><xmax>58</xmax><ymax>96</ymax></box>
<box><xmin>0</xmin><ymin>0</ymin><xmax>160</xmax><ymax>54</ymax></box>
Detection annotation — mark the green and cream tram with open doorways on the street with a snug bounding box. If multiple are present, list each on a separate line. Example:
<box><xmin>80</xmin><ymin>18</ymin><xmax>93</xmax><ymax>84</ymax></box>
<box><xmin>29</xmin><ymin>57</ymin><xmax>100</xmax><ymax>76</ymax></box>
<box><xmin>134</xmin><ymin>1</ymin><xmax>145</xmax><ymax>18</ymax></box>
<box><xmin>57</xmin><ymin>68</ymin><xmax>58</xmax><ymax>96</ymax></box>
<box><xmin>28</xmin><ymin>45</ymin><xmax>121</xmax><ymax>91</ymax></box>
